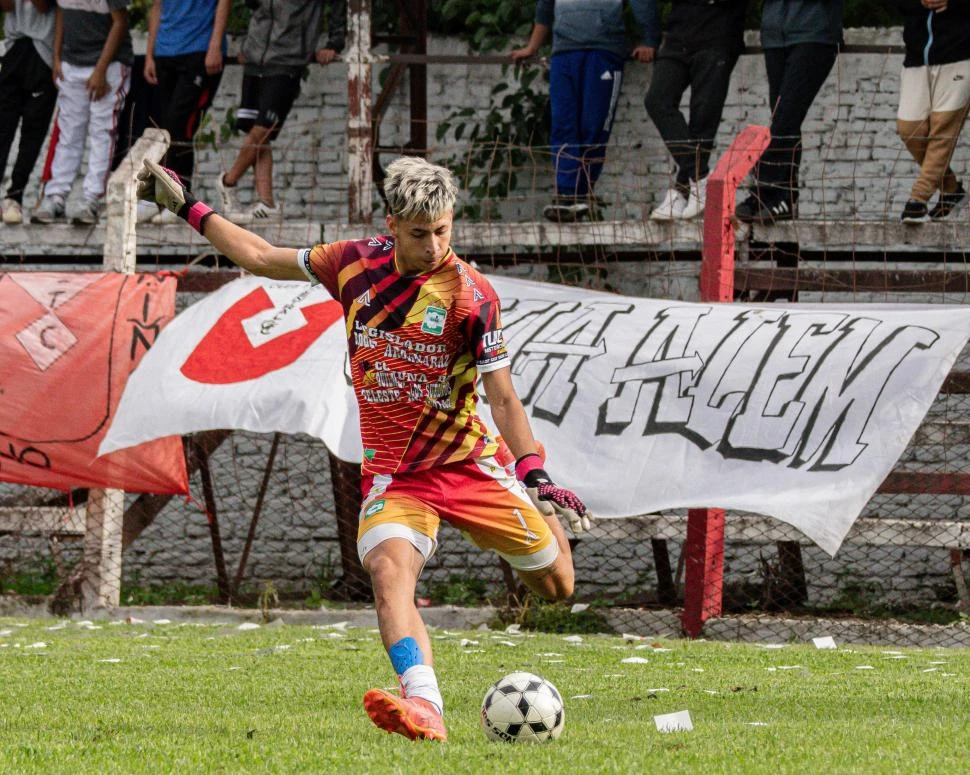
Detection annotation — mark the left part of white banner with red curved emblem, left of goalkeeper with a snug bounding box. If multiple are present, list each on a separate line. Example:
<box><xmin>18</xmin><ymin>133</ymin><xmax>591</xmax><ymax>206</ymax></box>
<box><xmin>98</xmin><ymin>277</ymin><xmax>362</xmax><ymax>462</ymax></box>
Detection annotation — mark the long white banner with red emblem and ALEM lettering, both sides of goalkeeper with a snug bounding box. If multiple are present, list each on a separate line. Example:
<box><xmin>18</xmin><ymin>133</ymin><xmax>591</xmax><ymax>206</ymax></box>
<box><xmin>101</xmin><ymin>276</ymin><xmax>970</xmax><ymax>554</ymax></box>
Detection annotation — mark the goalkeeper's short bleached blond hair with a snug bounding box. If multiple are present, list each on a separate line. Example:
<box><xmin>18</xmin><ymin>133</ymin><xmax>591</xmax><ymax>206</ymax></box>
<box><xmin>384</xmin><ymin>156</ymin><xmax>458</xmax><ymax>223</ymax></box>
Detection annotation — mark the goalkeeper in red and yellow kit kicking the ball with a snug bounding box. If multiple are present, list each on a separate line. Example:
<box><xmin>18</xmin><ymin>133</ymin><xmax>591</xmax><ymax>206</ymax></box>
<box><xmin>138</xmin><ymin>158</ymin><xmax>590</xmax><ymax>740</ymax></box>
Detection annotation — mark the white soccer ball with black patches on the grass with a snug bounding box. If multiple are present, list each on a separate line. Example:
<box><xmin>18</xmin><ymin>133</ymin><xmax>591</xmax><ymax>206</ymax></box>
<box><xmin>482</xmin><ymin>673</ymin><xmax>566</xmax><ymax>743</ymax></box>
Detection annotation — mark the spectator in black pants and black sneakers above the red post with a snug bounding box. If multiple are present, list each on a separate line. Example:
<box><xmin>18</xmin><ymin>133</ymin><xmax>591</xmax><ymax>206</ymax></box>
<box><xmin>735</xmin><ymin>0</ymin><xmax>843</xmax><ymax>224</ymax></box>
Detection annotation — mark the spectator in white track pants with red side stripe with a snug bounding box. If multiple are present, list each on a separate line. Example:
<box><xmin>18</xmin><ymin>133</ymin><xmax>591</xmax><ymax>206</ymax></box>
<box><xmin>33</xmin><ymin>0</ymin><xmax>133</xmax><ymax>224</ymax></box>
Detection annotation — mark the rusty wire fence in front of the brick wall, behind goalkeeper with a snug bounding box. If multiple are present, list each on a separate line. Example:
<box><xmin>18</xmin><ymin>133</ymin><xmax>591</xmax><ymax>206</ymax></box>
<box><xmin>0</xmin><ymin>33</ymin><xmax>970</xmax><ymax>645</ymax></box>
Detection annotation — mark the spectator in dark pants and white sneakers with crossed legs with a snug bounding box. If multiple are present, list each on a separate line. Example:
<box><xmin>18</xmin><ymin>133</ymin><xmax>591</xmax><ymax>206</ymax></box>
<box><xmin>644</xmin><ymin>0</ymin><xmax>748</xmax><ymax>221</ymax></box>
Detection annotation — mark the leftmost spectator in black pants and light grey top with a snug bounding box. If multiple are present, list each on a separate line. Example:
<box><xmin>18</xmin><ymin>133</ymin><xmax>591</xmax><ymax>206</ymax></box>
<box><xmin>0</xmin><ymin>0</ymin><xmax>57</xmax><ymax>224</ymax></box>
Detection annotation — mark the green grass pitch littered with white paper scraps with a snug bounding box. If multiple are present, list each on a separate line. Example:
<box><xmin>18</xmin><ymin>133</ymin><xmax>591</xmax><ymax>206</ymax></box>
<box><xmin>0</xmin><ymin>618</ymin><xmax>970</xmax><ymax>774</ymax></box>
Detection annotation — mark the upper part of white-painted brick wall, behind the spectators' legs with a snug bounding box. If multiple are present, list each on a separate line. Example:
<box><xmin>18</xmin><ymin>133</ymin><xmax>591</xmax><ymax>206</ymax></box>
<box><xmin>7</xmin><ymin>29</ymin><xmax>944</xmax><ymax>223</ymax></box>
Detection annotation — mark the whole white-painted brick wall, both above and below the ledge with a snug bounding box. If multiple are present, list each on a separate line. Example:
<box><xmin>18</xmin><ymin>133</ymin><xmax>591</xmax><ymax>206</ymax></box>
<box><xmin>0</xmin><ymin>30</ymin><xmax>968</xmax><ymax>616</ymax></box>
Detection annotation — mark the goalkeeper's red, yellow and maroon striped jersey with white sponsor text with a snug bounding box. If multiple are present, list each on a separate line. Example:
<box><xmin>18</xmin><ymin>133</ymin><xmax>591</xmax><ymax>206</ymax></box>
<box><xmin>299</xmin><ymin>236</ymin><xmax>509</xmax><ymax>474</ymax></box>
